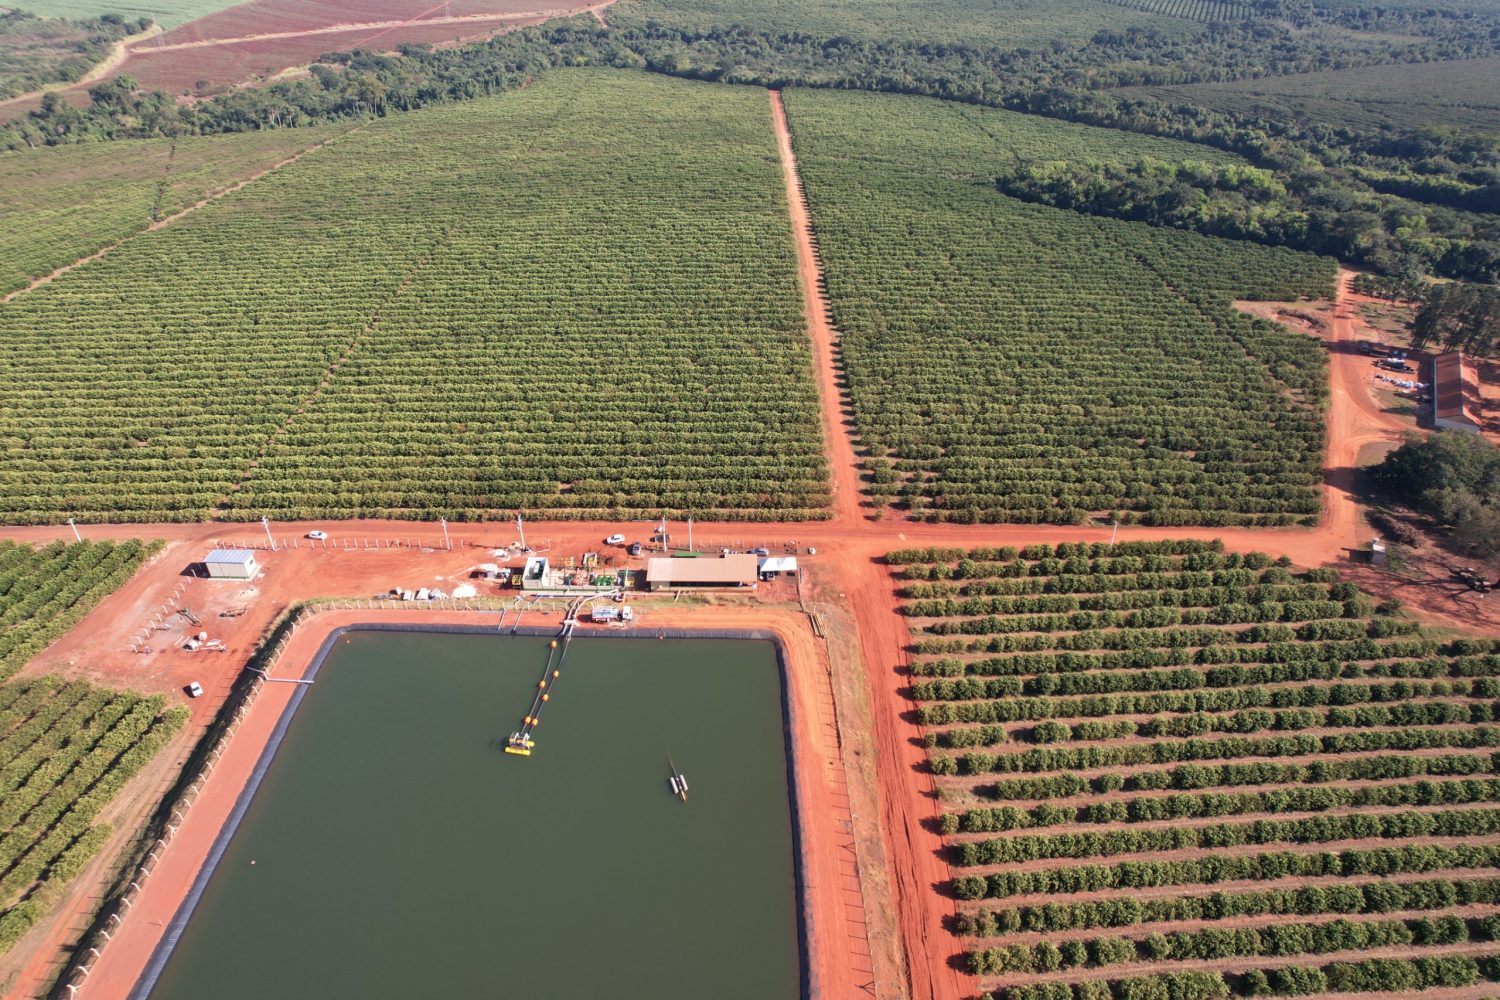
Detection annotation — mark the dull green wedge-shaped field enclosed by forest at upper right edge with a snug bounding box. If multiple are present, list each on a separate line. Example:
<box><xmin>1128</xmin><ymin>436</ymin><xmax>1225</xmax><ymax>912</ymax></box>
<box><xmin>1119</xmin><ymin>58</ymin><xmax>1500</xmax><ymax>132</ymax></box>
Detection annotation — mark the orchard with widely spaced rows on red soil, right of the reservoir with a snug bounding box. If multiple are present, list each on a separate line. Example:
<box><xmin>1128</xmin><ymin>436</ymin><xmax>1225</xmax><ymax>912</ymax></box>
<box><xmin>888</xmin><ymin>541</ymin><xmax>1500</xmax><ymax>1000</ymax></box>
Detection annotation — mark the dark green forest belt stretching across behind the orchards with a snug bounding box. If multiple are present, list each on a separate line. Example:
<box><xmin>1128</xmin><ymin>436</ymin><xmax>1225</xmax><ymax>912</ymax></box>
<box><xmin>0</xmin><ymin>0</ymin><xmax>1500</xmax><ymax>282</ymax></box>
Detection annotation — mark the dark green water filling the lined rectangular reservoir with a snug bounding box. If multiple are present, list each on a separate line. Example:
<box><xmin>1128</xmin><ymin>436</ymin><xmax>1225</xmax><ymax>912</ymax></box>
<box><xmin>150</xmin><ymin>633</ymin><xmax>801</xmax><ymax>1000</ymax></box>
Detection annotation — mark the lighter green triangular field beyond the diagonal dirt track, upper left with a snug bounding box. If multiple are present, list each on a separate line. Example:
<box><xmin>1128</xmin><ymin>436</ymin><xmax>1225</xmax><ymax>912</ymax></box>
<box><xmin>0</xmin><ymin>124</ymin><xmax>350</xmax><ymax>294</ymax></box>
